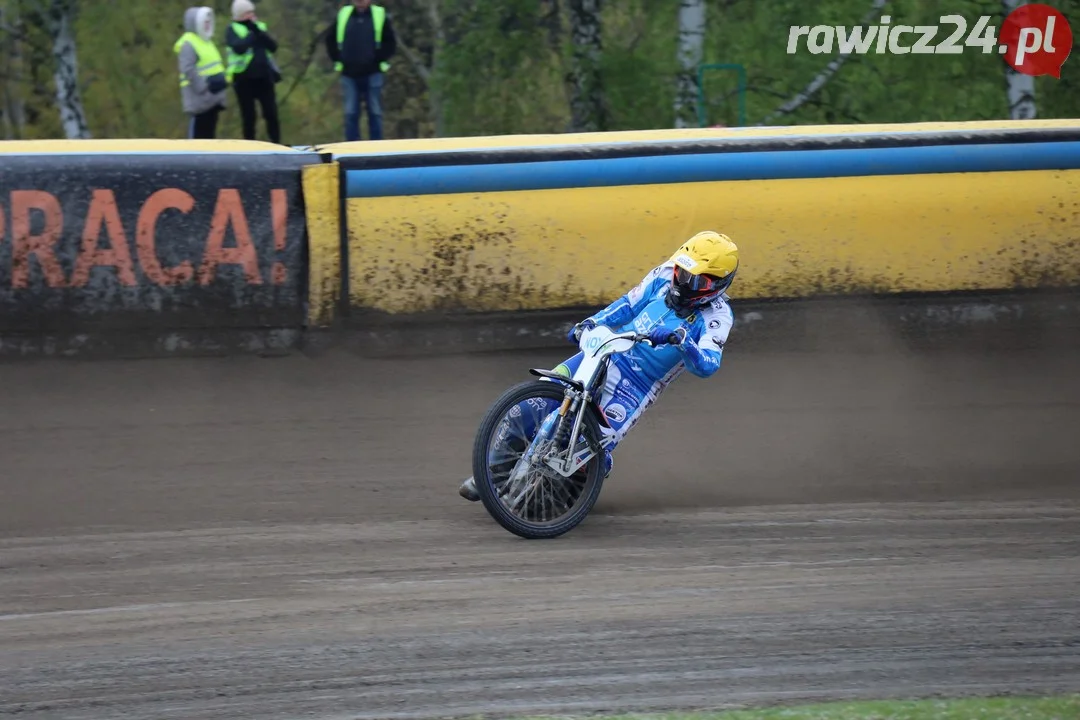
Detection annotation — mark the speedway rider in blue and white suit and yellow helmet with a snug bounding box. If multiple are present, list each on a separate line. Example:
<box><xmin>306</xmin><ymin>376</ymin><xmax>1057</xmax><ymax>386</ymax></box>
<box><xmin>458</xmin><ymin>230</ymin><xmax>739</xmax><ymax>501</ymax></box>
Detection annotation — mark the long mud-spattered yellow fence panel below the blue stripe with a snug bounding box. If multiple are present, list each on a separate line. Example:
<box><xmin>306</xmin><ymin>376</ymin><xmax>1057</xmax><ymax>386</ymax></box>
<box><xmin>347</xmin><ymin>171</ymin><xmax>1080</xmax><ymax>313</ymax></box>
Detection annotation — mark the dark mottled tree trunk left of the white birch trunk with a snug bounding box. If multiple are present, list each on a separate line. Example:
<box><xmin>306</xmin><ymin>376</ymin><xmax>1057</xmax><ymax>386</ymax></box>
<box><xmin>568</xmin><ymin>0</ymin><xmax>608</xmax><ymax>133</ymax></box>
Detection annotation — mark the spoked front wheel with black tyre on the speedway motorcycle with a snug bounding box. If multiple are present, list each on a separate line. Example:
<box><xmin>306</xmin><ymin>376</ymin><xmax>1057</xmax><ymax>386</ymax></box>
<box><xmin>473</xmin><ymin>380</ymin><xmax>604</xmax><ymax>540</ymax></box>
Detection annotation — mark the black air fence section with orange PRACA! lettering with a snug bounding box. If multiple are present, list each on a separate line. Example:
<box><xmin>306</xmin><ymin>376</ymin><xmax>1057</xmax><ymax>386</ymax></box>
<box><xmin>0</xmin><ymin>140</ymin><xmax>326</xmax><ymax>355</ymax></box>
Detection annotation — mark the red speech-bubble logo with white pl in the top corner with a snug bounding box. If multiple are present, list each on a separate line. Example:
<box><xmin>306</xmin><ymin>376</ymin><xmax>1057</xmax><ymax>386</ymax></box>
<box><xmin>998</xmin><ymin>3</ymin><xmax>1072</xmax><ymax>78</ymax></box>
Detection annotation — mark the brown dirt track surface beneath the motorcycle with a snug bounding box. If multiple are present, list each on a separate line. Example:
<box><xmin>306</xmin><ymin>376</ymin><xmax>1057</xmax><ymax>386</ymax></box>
<box><xmin>6</xmin><ymin>351</ymin><xmax>1080</xmax><ymax>719</ymax></box>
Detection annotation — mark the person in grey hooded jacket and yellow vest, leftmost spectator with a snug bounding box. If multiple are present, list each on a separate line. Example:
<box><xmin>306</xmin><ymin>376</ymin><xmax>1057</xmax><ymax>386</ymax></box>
<box><xmin>173</xmin><ymin>6</ymin><xmax>229</xmax><ymax>138</ymax></box>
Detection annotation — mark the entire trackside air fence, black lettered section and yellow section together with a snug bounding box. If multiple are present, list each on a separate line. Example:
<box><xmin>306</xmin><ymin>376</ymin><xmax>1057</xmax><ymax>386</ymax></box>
<box><xmin>0</xmin><ymin>120</ymin><xmax>1080</xmax><ymax>354</ymax></box>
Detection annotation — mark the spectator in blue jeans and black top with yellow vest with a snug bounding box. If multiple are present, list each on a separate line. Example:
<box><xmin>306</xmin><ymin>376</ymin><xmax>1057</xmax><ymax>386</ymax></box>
<box><xmin>326</xmin><ymin>0</ymin><xmax>397</xmax><ymax>140</ymax></box>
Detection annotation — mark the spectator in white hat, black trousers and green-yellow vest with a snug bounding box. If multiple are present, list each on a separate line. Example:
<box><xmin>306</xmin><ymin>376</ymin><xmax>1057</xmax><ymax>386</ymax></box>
<box><xmin>225</xmin><ymin>0</ymin><xmax>281</xmax><ymax>142</ymax></box>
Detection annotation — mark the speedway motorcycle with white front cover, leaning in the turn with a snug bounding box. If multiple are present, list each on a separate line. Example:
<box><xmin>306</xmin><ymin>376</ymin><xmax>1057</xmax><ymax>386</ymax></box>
<box><xmin>472</xmin><ymin>325</ymin><xmax>678</xmax><ymax>539</ymax></box>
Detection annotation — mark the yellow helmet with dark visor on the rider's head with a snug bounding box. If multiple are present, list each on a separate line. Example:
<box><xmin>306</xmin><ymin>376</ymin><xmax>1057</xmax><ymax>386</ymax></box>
<box><xmin>667</xmin><ymin>230</ymin><xmax>739</xmax><ymax>316</ymax></box>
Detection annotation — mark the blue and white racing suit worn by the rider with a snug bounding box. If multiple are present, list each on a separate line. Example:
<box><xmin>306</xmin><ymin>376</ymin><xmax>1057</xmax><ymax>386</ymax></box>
<box><xmin>555</xmin><ymin>262</ymin><xmax>734</xmax><ymax>470</ymax></box>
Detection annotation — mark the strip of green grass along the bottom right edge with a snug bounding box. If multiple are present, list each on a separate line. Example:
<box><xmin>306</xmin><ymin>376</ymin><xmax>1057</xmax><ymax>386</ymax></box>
<box><xmin>514</xmin><ymin>695</ymin><xmax>1080</xmax><ymax>720</ymax></box>
